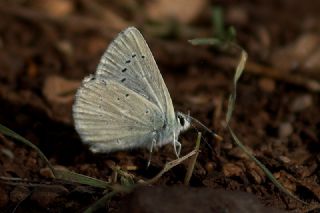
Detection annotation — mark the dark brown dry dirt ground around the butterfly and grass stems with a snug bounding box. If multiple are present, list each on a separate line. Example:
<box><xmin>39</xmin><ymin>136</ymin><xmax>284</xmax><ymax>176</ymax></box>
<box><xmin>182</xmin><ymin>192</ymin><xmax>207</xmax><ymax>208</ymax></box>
<box><xmin>0</xmin><ymin>0</ymin><xmax>320</xmax><ymax>213</ymax></box>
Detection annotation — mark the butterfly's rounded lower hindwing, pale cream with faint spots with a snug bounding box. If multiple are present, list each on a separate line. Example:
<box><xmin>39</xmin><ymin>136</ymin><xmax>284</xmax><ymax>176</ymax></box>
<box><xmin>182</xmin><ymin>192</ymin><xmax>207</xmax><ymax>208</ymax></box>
<box><xmin>73</xmin><ymin>77</ymin><xmax>165</xmax><ymax>152</ymax></box>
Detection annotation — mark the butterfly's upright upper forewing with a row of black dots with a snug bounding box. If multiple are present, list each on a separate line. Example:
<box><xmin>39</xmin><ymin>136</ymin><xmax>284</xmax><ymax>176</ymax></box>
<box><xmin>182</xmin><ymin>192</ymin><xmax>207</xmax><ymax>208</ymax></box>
<box><xmin>96</xmin><ymin>27</ymin><xmax>174</xmax><ymax>124</ymax></box>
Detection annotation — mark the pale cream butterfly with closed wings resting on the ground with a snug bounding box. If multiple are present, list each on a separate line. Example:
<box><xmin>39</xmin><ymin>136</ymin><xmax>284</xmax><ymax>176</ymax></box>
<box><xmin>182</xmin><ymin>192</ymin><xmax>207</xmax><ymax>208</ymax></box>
<box><xmin>73</xmin><ymin>27</ymin><xmax>190</xmax><ymax>156</ymax></box>
